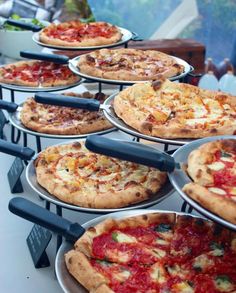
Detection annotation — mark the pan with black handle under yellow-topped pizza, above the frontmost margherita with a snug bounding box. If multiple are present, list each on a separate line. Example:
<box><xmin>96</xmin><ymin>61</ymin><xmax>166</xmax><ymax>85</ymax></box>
<box><xmin>0</xmin><ymin>140</ymin><xmax>173</xmax><ymax>213</ymax></box>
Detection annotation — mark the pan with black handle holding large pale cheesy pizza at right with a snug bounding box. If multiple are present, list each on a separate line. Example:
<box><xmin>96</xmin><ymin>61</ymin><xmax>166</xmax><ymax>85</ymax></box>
<box><xmin>35</xmin><ymin>93</ymin><xmax>192</xmax><ymax>145</ymax></box>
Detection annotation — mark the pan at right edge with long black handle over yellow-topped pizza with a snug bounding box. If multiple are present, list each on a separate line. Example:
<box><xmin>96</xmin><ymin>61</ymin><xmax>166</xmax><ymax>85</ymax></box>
<box><xmin>85</xmin><ymin>135</ymin><xmax>236</xmax><ymax>231</ymax></box>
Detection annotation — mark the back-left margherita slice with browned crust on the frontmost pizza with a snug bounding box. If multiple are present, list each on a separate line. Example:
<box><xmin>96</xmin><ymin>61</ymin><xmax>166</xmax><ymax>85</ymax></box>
<box><xmin>75</xmin><ymin>214</ymin><xmax>175</xmax><ymax>265</ymax></box>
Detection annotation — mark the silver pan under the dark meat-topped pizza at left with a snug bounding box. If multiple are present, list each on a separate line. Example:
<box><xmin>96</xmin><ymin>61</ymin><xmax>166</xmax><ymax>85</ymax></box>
<box><xmin>8</xmin><ymin>103</ymin><xmax>116</xmax><ymax>139</ymax></box>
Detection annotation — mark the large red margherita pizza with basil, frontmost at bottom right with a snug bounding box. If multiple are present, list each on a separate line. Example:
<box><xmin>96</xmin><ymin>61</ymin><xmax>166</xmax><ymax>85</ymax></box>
<box><xmin>65</xmin><ymin>212</ymin><xmax>236</xmax><ymax>293</ymax></box>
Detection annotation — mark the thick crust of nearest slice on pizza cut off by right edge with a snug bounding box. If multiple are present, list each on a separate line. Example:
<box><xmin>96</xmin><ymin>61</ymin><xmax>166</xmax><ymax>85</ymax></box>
<box><xmin>183</xmin><ymin>182</ymin><xmax>236</xmax><ymax>225</ymax></box>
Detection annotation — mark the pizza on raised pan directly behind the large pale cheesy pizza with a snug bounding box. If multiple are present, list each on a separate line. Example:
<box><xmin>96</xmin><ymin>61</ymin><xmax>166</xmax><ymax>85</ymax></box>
<box><xmin>77</xmin><ymin>48</ymin><xmax>184</xmax><ymax>81</ymax></box>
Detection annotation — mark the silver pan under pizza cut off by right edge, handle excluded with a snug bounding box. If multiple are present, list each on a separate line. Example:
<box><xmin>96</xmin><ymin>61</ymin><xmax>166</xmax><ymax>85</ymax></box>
<box><xmin>168</xmin><ymin>135</ymin><xmax>236</xmax><ymax>231</ymax></box>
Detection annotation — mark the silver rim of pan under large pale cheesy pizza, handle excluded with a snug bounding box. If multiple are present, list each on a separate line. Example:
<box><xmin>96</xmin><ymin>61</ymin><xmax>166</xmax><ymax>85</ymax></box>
<box><xmin>103</xmin><ymin>93</ymin><xmax>192</xmax><ymax>145</ymax></box>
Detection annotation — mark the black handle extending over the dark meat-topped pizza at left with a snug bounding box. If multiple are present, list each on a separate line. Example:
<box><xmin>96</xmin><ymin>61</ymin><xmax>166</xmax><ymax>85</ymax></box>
<box><xmin>34</xmin><ymin>92</ymin><xmax>100</xmax><ymax>111</ymax></box>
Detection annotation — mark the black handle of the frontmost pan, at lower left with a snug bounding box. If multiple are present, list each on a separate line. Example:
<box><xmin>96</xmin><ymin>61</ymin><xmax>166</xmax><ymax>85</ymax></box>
<box><xmin>8</xmin><ymin>197</ymin><xmax>85</xmax><ymax>243</ymax></box>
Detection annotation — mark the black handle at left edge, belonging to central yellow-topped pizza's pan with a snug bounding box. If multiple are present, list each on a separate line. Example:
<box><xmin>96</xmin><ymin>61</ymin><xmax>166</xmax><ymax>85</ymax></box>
<box><xmin>0</xmin><ymin>139</ymin><xmax>35</xmax><ymax>161</ymax></box>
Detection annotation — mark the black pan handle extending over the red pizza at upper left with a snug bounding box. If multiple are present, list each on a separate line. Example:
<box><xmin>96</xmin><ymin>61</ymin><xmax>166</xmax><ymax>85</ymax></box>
<box><xmin>20</xmin><ymin>51</ymin><xmax>69</xmax><ymax>64</ymax></box>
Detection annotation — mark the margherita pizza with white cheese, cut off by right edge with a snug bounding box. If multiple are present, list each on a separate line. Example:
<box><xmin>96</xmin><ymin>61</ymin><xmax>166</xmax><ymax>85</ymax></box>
<box><xmin>183</xmin><ymin>139</ymin><xmax>236</xmax><ymax>225</ymax></box>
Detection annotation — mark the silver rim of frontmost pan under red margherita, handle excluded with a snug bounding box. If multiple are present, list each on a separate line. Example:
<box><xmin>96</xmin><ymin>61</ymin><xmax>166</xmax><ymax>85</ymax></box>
<box><xmin>55</xmin><ymin>210</ymin><xmax>211</xmax><ymax>293</ymax></box>
